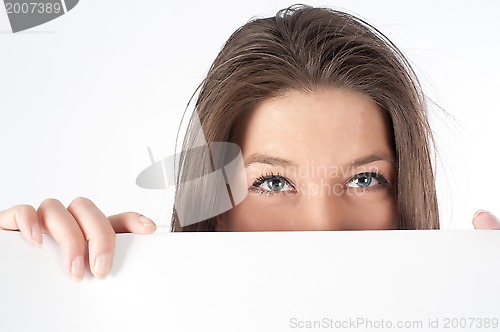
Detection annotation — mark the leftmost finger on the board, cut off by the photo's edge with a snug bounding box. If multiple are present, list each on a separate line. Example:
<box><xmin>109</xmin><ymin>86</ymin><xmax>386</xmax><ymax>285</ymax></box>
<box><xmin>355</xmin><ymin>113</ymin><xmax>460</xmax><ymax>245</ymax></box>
<box><xmin>0</xmin><ymin>205</ymin><xmax>43</xmax><ymax>247</ymax></box>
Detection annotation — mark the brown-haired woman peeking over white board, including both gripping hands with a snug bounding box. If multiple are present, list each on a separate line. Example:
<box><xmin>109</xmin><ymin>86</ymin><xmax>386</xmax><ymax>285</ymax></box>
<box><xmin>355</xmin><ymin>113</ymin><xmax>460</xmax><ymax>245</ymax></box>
<box><xmin>0</xmin><ymin>6</ymin><xmax>500</xmax><ymax>280</ymax></box>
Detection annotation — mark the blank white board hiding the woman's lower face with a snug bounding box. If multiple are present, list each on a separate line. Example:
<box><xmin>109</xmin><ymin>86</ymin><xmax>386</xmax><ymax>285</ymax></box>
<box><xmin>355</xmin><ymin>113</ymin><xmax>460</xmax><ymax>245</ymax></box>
<box><xmin>0</xmin><ymin>231</ymin><xmax>500</xmax><ymax>332</ymax></box>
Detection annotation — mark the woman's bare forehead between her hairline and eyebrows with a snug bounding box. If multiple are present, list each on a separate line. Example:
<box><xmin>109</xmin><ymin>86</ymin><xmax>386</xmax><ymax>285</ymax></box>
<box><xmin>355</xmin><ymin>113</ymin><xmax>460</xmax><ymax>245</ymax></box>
<box><xmin>234</xmin><ymin>89</ymin><xmax>393</xmax><ymax>164</ymax></box>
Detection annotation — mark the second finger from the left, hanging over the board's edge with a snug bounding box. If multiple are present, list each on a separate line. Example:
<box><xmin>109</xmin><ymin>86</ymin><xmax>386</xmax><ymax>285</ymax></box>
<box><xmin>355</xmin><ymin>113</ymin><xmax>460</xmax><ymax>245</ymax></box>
<box><xmin>38</xmin><ymin>199</ymin><xmax>87</xmax><ymax>281</ymax></box>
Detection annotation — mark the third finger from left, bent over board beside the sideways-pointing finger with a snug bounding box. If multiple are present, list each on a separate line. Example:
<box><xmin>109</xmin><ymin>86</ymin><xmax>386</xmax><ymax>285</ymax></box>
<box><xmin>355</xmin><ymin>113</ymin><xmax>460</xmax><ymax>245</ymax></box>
<box><xmin>68</xmin><ymin>197</ymin><xmax>116</xmax><ymax>279</ymax></box>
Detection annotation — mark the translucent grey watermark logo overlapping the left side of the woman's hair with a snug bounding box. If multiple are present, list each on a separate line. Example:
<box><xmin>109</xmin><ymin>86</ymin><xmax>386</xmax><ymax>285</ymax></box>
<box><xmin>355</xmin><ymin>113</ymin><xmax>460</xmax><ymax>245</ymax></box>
<box><xmin>136</xmin><ymin>116</ymin><xmax>248</xmax><ymax>226</ymax></box>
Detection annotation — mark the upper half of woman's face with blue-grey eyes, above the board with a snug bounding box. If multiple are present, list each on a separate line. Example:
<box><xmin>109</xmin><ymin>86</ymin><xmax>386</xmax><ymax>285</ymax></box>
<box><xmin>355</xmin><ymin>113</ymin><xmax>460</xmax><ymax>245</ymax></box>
<box><xmin>216</xmin><ymin>89</ymin><xmax>397</xmax><ymax>231</ymax></box>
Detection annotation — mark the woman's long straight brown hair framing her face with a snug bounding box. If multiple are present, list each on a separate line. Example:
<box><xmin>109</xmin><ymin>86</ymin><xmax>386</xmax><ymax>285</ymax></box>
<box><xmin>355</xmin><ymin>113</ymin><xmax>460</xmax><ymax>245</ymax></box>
<box><xmin>172</xmin><ymin>5</ymin><xmax>439</xmax><ymax>231</ymax></box>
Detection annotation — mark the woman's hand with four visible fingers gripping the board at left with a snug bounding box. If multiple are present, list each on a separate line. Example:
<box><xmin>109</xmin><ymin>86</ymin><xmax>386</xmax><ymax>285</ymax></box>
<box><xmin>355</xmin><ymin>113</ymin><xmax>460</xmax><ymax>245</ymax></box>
<box><xmin>0</xmin><ymin>197</ymin><xmax>156</xmax><ymax>281</ymax></box>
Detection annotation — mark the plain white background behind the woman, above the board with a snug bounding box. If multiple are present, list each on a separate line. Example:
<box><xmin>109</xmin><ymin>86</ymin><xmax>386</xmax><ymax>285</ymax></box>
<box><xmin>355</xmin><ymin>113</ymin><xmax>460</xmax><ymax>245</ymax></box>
<box><xmin>0</xmin><ymin>0</ymin><xmax>500</xmax><ymax>229</ymax></box>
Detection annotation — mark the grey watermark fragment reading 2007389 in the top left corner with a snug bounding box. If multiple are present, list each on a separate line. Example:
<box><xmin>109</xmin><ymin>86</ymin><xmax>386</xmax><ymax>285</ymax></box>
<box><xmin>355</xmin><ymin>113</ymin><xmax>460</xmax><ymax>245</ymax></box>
<box><xmin>4</xmin><ymin>0</ymin><xmax>79</xmax><ymax>33</ymax></box>
